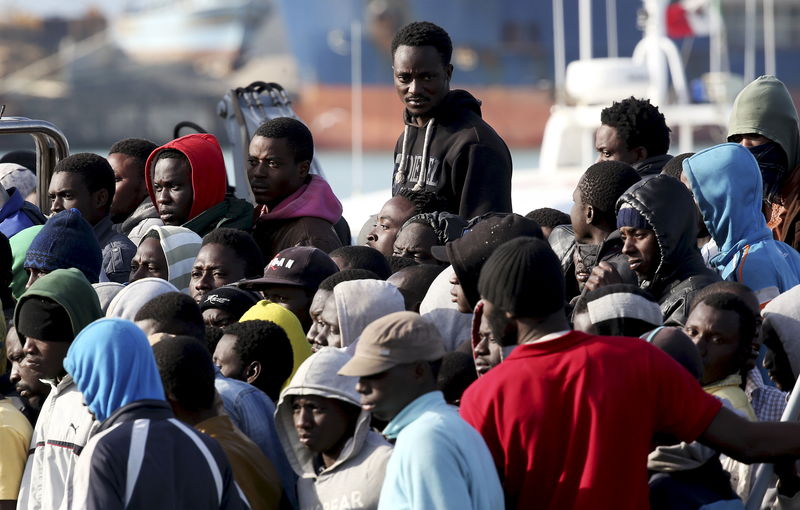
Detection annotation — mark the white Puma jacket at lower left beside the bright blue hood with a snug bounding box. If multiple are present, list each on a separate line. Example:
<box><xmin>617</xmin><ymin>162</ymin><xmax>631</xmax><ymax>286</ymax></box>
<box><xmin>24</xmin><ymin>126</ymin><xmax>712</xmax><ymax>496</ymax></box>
<box><xmin>17</xmin><ymin>375</ymin><xmax>96</xmax><ymax>510</ymax></box>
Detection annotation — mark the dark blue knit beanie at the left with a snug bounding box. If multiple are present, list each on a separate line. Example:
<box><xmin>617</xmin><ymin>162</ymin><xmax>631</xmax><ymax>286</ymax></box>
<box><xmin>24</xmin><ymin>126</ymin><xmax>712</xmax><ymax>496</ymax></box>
<box><xmin>23</xmin><ymin>209</ymin><xmax>103</xmax><ymax>283</ymax></box>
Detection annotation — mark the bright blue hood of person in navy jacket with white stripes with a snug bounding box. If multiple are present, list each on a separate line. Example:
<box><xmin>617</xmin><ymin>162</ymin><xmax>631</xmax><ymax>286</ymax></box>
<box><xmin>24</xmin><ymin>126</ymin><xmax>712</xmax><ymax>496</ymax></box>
<box><xmin>64</xmin><ymin>319</ymin><xmax>165</xmax><ymax>422</ymax></box>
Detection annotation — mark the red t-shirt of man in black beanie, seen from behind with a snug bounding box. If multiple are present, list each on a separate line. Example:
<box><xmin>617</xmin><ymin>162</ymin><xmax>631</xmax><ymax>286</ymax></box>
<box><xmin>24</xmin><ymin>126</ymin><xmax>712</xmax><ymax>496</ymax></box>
<box><xmin>461</xmin><ymin>331</ymin><xmax>722</xmax><ymax>510</ymax></box>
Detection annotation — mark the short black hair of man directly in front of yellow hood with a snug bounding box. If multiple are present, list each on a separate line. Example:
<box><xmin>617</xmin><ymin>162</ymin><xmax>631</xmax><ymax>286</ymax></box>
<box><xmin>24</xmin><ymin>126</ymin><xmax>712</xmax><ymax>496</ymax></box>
<box><xmin>225</xmin><ymin>320</ymin><xmax>294</xmax><ymax>401</ymax></box>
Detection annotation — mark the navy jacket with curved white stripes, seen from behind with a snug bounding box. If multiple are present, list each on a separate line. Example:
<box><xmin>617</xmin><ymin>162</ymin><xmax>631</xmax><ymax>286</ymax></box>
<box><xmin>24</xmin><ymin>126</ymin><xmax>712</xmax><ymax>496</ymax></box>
<box><xmin>68</xmin><ymin>400</ymin><xmax>249</xmax><ymax>510</ymax></box>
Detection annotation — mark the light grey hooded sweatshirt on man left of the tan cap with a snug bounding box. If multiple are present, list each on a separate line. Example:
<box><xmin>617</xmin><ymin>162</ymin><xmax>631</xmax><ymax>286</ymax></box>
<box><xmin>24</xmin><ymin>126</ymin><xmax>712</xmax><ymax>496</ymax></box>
<box><xmin>275</xmin><ymin>347</ymin><xmax>392</xmax><ymax>510</ymax></box>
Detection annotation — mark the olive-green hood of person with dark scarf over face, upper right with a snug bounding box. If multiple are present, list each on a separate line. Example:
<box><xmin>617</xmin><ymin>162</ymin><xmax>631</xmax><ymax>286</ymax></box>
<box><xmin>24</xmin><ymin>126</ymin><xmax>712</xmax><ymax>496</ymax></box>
<box><xmin>728</xmin><ymin>76</ymin><xmax>800</xmax><ymax>173</ymax></box>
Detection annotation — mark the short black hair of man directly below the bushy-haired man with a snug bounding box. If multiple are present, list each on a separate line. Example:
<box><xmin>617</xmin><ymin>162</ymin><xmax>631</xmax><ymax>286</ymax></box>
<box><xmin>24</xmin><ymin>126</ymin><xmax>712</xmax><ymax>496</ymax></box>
<box><xmin>578</xmin><ymin>161</ymin><xmax>642</xmax><ymax>225</ymax></box>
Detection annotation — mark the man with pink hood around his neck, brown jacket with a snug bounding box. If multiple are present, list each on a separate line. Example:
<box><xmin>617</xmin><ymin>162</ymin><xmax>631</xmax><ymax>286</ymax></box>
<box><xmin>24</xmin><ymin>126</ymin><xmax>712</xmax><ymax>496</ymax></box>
<box><xmin>247</xmin><ymin>117</ymin><xmax>342</xmax><ymax>259</ymax></box>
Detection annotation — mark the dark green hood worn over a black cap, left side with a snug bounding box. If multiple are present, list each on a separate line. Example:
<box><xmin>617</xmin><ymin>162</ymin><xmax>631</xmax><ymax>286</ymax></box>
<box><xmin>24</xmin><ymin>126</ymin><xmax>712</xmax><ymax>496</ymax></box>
<box><xmin>14</xmin><ymin>268</ymin><xmax>103</xmax><ymax>336</ymax></box>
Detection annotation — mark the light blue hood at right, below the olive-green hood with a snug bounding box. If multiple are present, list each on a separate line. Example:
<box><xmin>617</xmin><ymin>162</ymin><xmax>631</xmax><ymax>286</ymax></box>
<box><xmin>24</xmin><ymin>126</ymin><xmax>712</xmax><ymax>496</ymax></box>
<box><xmin>683</xmin><ymin>143</ymin><xmax>772</xmax><ymax>258</ymax></box>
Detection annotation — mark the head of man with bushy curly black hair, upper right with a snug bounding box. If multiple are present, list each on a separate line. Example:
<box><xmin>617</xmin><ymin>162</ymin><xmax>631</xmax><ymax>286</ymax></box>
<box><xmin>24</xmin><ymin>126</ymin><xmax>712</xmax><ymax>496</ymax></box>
<box><xmin>594</xmin><ymin>96</ymin><xmax>672</xmax><ymax>178</ymax></box>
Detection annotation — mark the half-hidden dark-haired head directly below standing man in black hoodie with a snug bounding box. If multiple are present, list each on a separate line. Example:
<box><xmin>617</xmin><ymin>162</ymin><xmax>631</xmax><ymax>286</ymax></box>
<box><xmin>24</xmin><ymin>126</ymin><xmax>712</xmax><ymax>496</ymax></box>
<box><xmin>392</xmin><ymin>212</ymin><xmax>467</xmax><ymax>264</ymax></box>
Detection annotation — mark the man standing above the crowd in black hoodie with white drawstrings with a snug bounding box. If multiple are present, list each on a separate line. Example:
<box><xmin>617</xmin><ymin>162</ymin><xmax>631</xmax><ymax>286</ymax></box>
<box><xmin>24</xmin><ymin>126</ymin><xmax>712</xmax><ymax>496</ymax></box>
<box><xmin>392</xmin><ymin>21</ymin><xmax>511</xmax><ymax>219</ymax></box>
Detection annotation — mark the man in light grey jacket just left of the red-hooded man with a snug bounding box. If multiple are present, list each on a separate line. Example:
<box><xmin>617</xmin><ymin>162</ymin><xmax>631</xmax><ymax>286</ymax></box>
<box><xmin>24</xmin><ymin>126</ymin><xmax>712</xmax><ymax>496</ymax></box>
<box><xmin>106</xmin><ymin>138</ymin><xmax>164</xmax><ymax>246</ymax></box>
